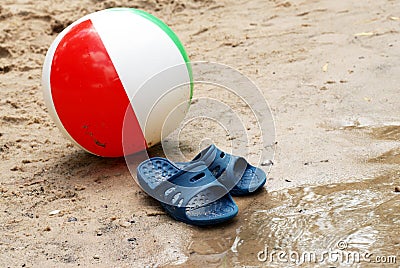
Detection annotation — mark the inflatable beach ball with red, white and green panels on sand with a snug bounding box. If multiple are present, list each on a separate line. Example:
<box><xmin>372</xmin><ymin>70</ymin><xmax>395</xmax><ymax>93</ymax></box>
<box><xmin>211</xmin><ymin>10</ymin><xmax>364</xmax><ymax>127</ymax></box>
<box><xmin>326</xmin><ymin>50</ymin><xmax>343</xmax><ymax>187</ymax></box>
<box><xmin>42</xmin><ymin>8</ymin><xmax>193</xmax><ymax>157</ymax></box>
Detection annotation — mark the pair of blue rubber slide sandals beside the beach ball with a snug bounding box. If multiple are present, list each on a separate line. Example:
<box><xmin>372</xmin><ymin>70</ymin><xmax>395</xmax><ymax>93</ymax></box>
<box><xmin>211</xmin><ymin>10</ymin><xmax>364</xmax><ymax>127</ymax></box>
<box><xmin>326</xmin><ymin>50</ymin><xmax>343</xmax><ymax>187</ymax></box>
<box><xmin>137</xmin><ymin>145</ymin><xmax>266</xmax><ymax>225</ymax></box>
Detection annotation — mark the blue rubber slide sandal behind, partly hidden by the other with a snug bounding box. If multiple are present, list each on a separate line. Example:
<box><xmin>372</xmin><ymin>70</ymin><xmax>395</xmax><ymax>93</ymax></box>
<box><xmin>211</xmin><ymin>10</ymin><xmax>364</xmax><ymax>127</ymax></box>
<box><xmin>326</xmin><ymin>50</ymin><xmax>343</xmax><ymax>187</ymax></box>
<box><xmin>177</xmin><ymin>144</ymin><xmax>267</xmax><ymax>196</ymax></box>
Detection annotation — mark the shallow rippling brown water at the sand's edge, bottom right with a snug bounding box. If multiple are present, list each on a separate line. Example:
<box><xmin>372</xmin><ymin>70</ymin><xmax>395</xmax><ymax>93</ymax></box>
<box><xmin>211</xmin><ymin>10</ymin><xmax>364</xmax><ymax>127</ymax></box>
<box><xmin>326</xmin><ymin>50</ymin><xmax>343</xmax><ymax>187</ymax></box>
<box><xmin>185</xmin><ymin>171</ymin><xmax>400</xmax><ymax>267</ymax></box>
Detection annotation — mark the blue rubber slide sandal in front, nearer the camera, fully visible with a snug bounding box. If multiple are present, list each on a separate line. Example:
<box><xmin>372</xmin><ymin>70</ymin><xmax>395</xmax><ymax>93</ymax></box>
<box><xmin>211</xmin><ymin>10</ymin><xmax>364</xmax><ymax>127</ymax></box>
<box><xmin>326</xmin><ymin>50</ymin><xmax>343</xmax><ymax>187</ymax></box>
<box><xmin>137</xmin><ymin>157</ymin><xmax>238</xmax><ymax>225</ymax></box>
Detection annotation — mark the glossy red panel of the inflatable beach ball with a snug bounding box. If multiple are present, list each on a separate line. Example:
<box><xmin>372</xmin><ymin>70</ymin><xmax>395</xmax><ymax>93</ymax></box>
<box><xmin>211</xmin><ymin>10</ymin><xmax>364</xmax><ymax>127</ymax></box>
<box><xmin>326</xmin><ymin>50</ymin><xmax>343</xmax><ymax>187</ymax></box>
<box><xmin>50</xmin><ymin>20</ymin><xmax>146</xmax><ymax>157</ymax></box>
